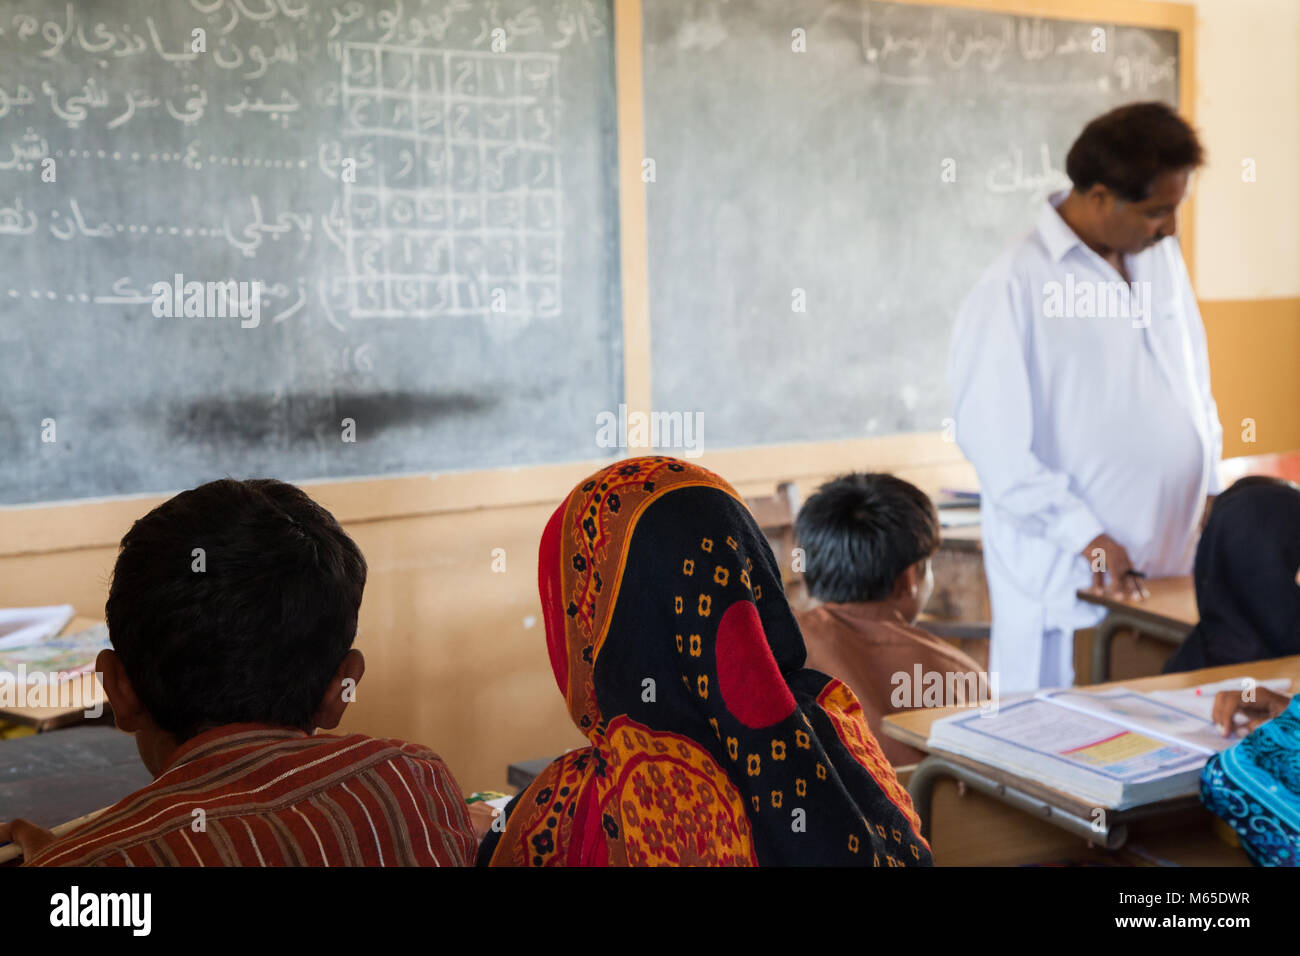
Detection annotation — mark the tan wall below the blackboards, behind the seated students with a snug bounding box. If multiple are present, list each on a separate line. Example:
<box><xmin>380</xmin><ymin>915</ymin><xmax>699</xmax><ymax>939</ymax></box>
<box><xmin>0</xmin><ymin>437</ymin><xmax>972</xmax><ymax>791</ymax></box>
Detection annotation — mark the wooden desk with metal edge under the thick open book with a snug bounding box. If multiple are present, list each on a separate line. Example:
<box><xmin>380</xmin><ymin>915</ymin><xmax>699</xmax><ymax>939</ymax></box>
<box><xmin>881</xmin><ymin>657</ymin><xmax>1300</xmax><ymax>866</ymax></box>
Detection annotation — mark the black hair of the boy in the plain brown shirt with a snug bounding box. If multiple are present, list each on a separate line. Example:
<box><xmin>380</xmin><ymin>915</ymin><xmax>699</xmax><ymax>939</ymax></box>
<box><xmin>794</xmin><ymin>473</ymin><xmax>939</xmax><ymax>604</ymax></box>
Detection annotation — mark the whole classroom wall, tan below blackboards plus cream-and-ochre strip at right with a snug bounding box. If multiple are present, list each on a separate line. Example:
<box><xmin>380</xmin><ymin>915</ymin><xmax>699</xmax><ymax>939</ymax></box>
<box><xmin>0</xmin><ymin>0</ymin><xmax>1300</xmax><ymax>791</ymax></box>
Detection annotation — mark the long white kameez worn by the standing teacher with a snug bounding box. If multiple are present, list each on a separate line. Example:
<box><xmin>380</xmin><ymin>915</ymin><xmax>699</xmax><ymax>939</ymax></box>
<box><xmin>948</xmin><ymin>193</ymin><xmax>1223</xmax><ymax>693</ymax></box>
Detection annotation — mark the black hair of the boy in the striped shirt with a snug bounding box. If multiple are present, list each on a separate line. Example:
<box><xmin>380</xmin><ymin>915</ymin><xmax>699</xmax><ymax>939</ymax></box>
<box><xmin>105</xmin><ymin>479</ymin><xmax>365</xmax><ymax>741</ymax></box>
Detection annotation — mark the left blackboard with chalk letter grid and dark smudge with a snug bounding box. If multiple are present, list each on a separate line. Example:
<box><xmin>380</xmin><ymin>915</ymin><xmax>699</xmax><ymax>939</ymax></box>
<box><xmin>0</xmin><ymin>0</ymin><xmax>623</xmax><ymax>503</ymax></box>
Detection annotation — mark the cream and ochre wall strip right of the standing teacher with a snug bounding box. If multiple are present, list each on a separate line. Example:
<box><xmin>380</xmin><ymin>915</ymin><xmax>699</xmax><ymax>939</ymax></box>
<box><xmin>1195</xmin><ymin>0</ymin><xmax>1300</xmax><ymax>457</ymax></box>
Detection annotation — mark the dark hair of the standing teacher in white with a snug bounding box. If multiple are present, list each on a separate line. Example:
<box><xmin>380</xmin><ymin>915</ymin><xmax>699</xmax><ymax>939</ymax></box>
<box><xmin>1065</xmin><ymin>101</ymin><xmax>1205</xmax><ymax>203</ymax></box>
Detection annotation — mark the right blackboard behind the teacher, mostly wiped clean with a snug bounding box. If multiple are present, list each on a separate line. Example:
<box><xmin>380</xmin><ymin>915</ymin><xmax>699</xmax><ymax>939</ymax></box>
<box><xmin>644</xmin><ymin>0</ymin><xmax>1178</xmax><ymax>447</ymax></box>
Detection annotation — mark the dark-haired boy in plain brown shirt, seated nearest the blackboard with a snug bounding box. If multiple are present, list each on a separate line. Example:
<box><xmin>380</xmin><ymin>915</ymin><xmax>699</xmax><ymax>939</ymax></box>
<box><xmin>794</xmin><ymin>475</ymin><xmax>980</xmax><ymax>766</ymax></box>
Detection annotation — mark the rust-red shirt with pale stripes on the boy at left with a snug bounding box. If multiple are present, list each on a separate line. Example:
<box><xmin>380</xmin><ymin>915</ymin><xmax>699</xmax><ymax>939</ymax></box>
<box><xmin>29</xmin><ymin>723</ymin><xmax>477</xmax><ymax>866</ymax></box>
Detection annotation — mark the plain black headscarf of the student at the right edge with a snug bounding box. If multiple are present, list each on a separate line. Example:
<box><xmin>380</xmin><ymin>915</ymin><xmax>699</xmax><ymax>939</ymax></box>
<box><xmin>1165</xmin><ymin>476</ymin><xmax>1300</xmax><ymax>674</ymax></box>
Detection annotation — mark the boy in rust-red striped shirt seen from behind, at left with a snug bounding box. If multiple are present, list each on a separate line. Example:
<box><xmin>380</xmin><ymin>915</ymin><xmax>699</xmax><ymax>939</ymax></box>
<box><xmin>0</xmin><ymin>479</ymin><xmax>477</xmax><ymax>866</ymax></box>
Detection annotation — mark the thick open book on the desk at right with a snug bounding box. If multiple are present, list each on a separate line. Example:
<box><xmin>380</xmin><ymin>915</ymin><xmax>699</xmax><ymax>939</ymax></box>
<box><xmin>927</xmin><ymin>679</ymin><xmax>1291</xmax><ymax>809</ymax></box>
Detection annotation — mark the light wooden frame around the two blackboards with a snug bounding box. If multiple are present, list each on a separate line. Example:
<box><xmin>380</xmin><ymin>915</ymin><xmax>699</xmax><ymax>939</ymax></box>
<box><xmin>0</xmin><ymin>0</ymin><xmax>1196</xmax><ymax>557</ymax></box>
